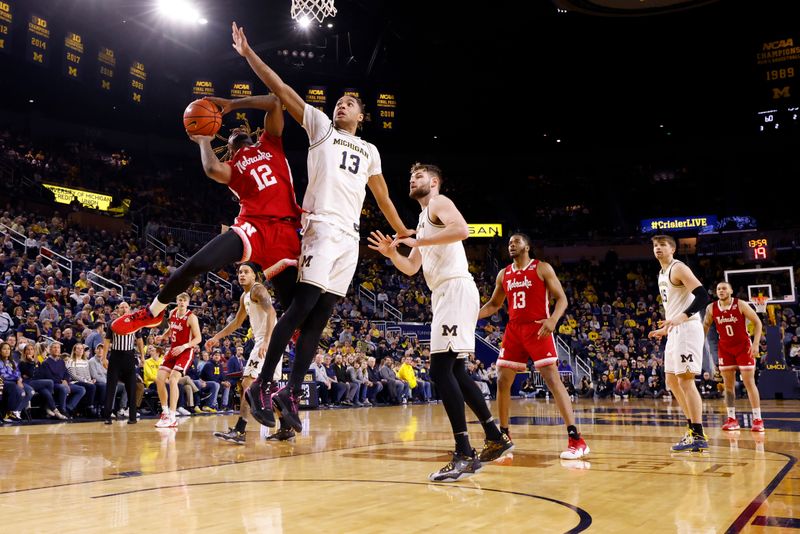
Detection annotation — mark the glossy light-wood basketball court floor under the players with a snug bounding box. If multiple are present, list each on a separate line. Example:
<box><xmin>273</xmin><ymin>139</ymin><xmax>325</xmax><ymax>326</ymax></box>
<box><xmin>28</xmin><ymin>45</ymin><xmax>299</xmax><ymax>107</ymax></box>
<box><xmin>0</xmin><ymin>400</ymin><xmax>800</xmax><ymax>533</ymax></box>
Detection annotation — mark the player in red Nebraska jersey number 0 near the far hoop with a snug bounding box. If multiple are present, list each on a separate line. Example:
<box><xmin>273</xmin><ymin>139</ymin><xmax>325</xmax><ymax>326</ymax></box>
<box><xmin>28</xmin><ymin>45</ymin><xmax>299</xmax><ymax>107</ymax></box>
<box><xmin>703</xmin><ymin>282</ymin><xmax>764</xmax><ymax>432</ymax></box>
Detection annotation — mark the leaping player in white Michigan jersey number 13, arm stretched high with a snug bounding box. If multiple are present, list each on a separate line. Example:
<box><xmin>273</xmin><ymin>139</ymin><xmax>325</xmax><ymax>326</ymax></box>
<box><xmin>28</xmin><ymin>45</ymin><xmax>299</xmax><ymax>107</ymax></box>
<box><xmin>225</xmin><ymin>22</ymin><xmax>414</xmax><ymax>432</ymax></box>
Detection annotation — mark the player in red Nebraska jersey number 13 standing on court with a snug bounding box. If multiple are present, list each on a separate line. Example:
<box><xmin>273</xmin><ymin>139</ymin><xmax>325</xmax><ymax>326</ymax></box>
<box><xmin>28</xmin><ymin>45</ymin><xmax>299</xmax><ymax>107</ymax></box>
<box><xmin>478</xmin><ymin>233</ymin><xmax>589</xmax><ymax>460</ymax></box>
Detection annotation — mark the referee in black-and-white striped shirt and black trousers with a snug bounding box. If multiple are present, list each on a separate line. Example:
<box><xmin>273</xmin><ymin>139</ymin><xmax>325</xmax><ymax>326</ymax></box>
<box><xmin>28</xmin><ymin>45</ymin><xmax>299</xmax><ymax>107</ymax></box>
<box><xmin>103</xmin><ymin>301</ymin><xmax>144</xmax><ymax>425</ymax></box>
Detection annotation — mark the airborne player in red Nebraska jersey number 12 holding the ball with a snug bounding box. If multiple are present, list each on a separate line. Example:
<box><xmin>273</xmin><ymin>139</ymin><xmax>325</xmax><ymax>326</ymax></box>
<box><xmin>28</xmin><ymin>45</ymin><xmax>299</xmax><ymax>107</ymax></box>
<box><xmin>116</xmin><ymin>95</ymin><xmax>300</xmax><ymax>335</ymax></box>
